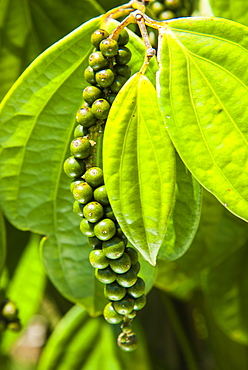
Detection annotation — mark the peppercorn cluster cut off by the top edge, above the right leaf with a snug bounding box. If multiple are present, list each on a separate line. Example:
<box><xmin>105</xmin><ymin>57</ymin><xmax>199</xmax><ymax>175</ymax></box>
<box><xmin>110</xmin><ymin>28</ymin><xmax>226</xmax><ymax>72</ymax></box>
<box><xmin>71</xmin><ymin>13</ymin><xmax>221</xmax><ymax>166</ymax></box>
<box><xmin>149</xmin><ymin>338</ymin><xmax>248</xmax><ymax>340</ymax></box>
<box><xmin>149</xmin><ymin>0</ymin><xmax>193</xmax><ymax>21</ymax></box>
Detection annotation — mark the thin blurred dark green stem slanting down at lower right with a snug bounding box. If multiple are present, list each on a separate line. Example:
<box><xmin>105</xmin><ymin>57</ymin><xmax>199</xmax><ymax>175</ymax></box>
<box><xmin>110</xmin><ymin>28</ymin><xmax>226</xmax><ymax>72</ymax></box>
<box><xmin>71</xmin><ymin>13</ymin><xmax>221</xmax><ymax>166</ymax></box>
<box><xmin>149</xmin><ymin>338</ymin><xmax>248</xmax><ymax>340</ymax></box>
<box><xmin>160</xmin><ymin>292</ymin><xmax>198</xmax><ymax>370</ymax></box>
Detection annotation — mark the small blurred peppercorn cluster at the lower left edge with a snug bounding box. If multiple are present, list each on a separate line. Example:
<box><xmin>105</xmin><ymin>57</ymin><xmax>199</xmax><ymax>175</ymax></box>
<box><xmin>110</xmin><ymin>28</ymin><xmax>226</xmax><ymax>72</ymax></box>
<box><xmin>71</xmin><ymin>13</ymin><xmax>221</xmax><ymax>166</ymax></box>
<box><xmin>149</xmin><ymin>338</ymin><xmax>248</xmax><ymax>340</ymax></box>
<box><xmin>0</xmin><ymin>298</ymin><xmax>21</xmax><ymax>332</ymax></box>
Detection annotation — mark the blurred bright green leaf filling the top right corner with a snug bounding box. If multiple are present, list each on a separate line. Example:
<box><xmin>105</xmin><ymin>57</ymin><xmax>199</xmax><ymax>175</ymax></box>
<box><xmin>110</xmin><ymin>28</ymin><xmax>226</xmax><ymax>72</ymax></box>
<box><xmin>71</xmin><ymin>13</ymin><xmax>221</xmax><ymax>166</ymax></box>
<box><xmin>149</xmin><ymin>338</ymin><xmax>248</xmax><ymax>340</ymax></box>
<box><xmin>210</xmin><ymin>0</ymin><xmax>248</xmax><ymax>26</ymax></box>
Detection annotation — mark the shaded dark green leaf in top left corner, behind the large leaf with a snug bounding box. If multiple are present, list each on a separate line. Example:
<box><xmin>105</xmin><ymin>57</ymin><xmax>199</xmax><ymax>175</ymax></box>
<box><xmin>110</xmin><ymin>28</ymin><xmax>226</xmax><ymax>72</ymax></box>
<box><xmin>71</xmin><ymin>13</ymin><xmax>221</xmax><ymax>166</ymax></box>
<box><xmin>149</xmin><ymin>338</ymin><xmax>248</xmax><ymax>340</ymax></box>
<box><xmin>0</xmin><ymin>0</ymin><xmax>103</xmax><ymax>100</ymax></box>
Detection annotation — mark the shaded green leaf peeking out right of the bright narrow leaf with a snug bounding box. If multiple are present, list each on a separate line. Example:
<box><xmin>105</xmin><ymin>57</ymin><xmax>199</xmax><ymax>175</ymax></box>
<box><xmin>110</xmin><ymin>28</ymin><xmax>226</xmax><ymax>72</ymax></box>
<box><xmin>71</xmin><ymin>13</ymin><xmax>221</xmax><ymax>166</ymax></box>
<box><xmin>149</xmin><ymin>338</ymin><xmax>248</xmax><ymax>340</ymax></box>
<box><xmin>158</xmin><ymin>156</ymin><xmax>202</xmax><ymax>261</ymax></box>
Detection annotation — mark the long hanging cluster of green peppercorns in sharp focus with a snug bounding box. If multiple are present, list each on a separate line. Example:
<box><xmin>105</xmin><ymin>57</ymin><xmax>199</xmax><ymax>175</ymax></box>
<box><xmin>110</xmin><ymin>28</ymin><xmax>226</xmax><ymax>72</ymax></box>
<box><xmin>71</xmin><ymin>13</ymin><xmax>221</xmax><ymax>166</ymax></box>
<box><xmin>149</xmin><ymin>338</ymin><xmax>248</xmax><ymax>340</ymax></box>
<box><xmin>64</xmin><ymin>29</ymin><xmax>146</xmax><ymax>351</ymax></box>
